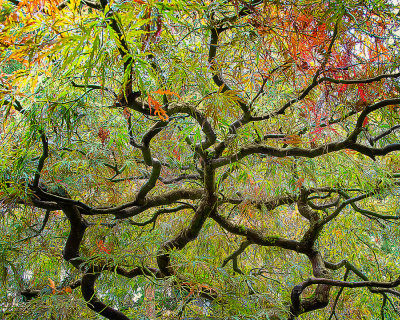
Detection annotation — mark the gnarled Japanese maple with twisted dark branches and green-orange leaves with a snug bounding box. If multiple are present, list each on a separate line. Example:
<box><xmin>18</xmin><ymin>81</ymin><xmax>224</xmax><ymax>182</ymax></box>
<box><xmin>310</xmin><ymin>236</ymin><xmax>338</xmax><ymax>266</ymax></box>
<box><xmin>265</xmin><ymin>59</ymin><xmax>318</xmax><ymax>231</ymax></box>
<box><xmin>0</xmin><ymin>1</ymin><xmax>400</xmax><ymax>319</ymax></box>
